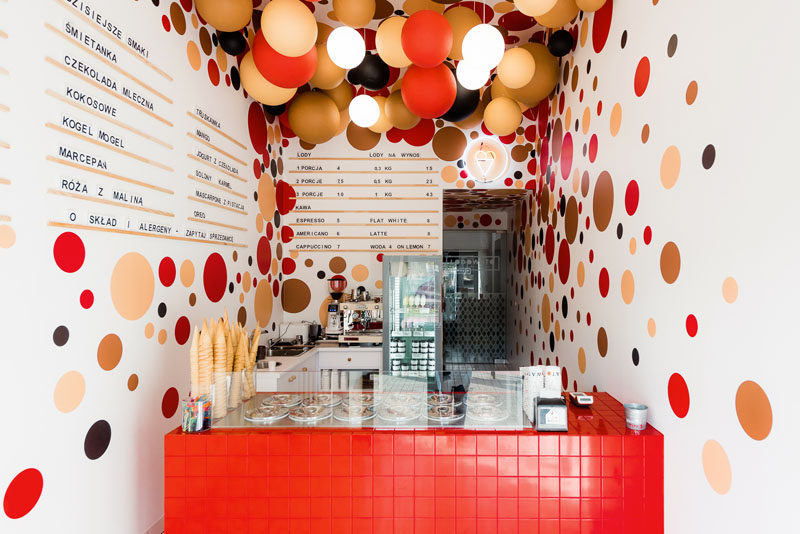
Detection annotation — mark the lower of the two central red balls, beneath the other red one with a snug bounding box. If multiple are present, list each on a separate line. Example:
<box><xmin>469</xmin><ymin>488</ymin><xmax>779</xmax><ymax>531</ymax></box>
<box><xmin>400</xmin><ymin>63</ymin><xmax>456</xmax><ymax>119</ymax></box>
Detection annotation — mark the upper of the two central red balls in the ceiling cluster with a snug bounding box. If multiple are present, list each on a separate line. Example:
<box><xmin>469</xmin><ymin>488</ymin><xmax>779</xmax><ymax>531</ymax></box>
<box><xmin>400</xmin><ymin>9</ymin><xmax>453</xmax><ymax>68</ymax></box>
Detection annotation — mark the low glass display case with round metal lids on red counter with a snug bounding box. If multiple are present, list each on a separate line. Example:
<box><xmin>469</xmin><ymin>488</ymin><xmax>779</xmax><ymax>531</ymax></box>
<box><xmin>213</xmin><ymin>371</ymin><xmax>529</xmax><ymax>430</ymax></box>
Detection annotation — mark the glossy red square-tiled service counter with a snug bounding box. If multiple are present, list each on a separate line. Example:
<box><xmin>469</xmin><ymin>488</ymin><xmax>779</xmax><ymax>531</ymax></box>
<box><xmin>164</xmin><ymin>393</ymin><xmax>664</xmax><ymax>534</ymax></box>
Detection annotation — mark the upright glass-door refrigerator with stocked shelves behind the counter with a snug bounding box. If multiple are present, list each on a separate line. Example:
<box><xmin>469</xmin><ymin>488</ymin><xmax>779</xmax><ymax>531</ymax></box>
<box><xmin>383</xmin><ymin>255</ymin><xmax>442</xmax><ymax>378</ymax></box>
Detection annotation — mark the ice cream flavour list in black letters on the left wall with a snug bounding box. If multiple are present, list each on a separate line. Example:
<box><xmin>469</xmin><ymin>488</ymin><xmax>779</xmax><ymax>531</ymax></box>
<box><xmin>42</xmin><ymin>0</ymin><xmax>252</xmax><ymax>251</ymax></box>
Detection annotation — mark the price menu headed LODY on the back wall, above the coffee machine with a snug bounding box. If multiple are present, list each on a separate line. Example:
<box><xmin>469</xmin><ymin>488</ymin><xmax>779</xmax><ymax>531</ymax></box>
<box><xmin>284</xmin><ymin>147</ymin><xmax>442</xmax><ymax>254</ymax></box>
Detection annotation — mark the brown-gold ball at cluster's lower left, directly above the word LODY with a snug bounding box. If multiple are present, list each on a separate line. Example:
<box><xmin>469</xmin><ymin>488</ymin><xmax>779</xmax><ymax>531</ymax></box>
<box><xmin>289</xmin><ymin>91</ymin><xmax>341</xmax><ymax>145</ymax></box>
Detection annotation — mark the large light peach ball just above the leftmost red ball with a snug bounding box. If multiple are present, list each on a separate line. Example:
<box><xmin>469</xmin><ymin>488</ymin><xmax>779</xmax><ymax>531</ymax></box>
<box><xmin>261</xmin><ymin>0</ymin><xmax>317</xmax><ymax>57</ymax></box>
